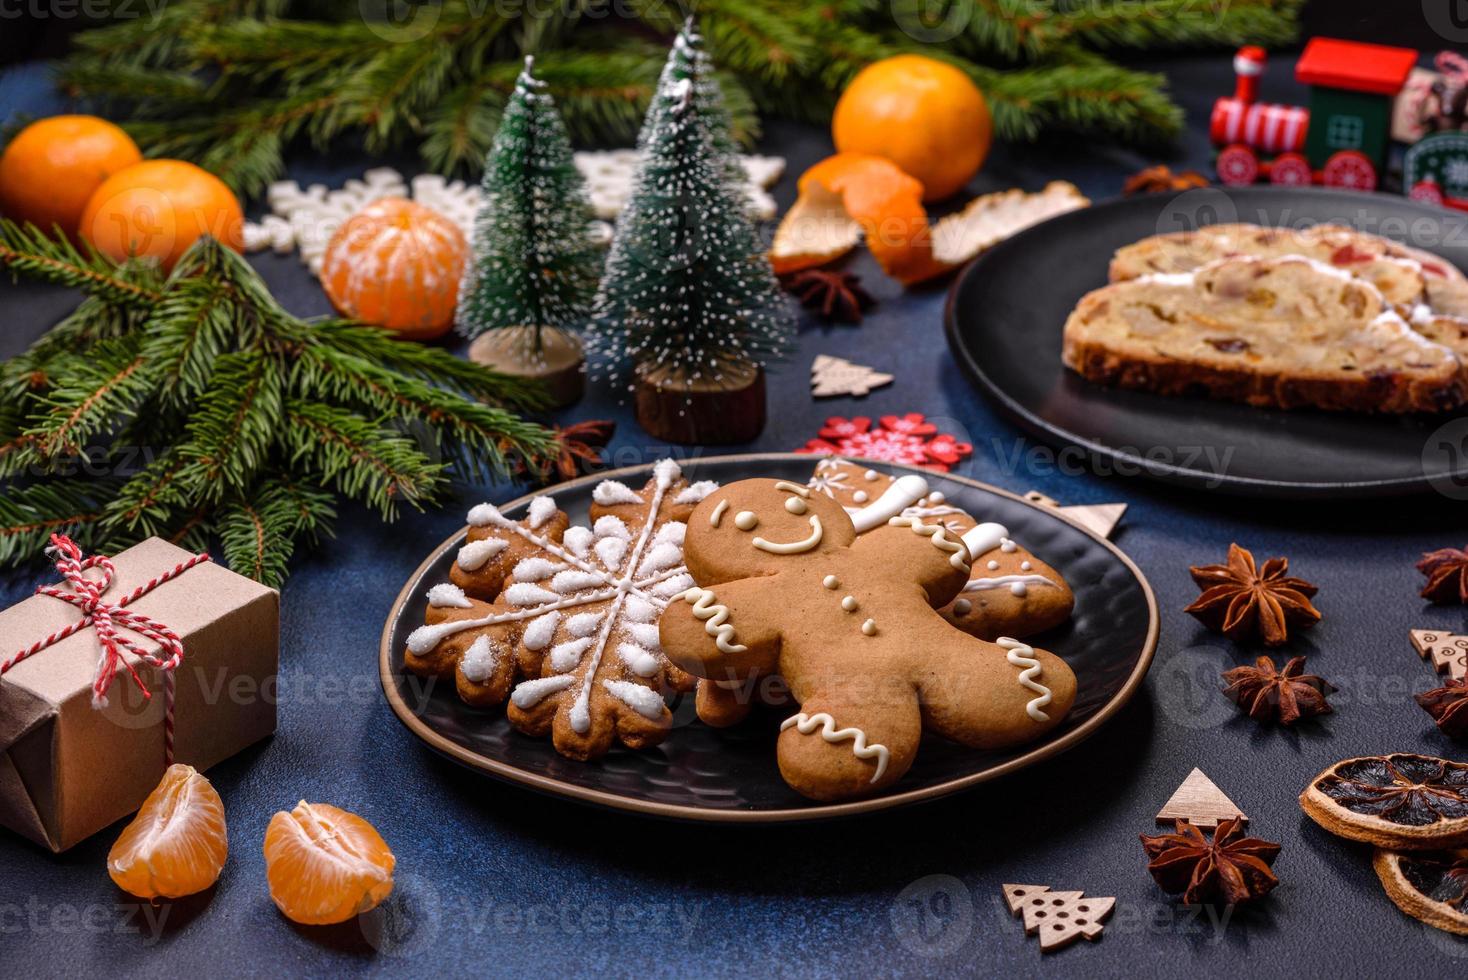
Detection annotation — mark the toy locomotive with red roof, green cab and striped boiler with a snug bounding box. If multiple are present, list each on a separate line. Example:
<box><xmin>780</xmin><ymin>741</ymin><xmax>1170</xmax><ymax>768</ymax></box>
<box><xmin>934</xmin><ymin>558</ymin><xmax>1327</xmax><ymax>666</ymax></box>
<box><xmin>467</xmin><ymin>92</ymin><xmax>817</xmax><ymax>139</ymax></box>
<box><xmin>1210</xmin><ymin>38</ymin><xmax>1417</xmax><ymax>191</ymax></box>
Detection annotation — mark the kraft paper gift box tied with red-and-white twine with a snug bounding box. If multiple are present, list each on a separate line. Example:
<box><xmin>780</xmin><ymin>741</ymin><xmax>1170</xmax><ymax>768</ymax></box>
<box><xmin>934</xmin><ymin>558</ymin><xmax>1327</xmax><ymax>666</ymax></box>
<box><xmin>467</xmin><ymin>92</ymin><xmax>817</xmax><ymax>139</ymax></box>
<box><xmin>0</xmin><ymin>538</ymin><xmax>280</xmax><ymax>852</ymax></box>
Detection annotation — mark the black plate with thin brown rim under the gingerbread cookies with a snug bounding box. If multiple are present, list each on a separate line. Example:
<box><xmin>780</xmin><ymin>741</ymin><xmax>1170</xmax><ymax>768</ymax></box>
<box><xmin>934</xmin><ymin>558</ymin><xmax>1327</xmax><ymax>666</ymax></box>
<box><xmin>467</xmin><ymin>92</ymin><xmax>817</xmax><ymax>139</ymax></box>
<box><xmin>380</xmin><ymin>453</ymin><xmax>1157</xmax><ymax>822</ymax></box>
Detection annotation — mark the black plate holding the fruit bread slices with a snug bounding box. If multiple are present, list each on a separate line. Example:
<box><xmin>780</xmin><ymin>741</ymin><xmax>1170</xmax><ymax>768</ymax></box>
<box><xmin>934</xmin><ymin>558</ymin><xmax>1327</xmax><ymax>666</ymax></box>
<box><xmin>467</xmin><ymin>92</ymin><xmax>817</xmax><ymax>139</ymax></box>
<box><xmin>945</xmin><ymin>188</ymin><xmax>1468</xmax><ymax>497</ymax></box>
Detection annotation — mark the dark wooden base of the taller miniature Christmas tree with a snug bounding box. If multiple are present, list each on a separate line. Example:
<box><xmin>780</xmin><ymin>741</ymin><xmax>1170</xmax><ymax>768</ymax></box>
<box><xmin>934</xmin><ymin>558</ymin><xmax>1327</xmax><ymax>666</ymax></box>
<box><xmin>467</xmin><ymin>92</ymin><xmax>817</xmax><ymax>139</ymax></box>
<box><xmin>634</xmin><ymin>364</ymin><xmax>765</xmax><ymax>446</ymax></box>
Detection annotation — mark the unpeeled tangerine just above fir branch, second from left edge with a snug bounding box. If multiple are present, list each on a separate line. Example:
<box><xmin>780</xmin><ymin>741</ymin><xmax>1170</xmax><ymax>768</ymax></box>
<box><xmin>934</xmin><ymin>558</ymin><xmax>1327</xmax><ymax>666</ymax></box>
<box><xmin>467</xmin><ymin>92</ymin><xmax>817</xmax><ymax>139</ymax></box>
<box><xmin>81</xmin><ymin>160</ymin><xmax>245</xmax><ymax>268</ymax></box>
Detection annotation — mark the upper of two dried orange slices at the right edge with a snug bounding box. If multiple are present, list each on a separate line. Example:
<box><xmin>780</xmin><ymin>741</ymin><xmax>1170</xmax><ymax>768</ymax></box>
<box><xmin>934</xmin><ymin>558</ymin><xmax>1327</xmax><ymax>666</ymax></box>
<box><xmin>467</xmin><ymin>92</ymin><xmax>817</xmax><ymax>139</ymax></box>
<box><xmin>1299</xmin><ymin>753</ymin><xmax>1468</xmax><ymax>851</ymax></box>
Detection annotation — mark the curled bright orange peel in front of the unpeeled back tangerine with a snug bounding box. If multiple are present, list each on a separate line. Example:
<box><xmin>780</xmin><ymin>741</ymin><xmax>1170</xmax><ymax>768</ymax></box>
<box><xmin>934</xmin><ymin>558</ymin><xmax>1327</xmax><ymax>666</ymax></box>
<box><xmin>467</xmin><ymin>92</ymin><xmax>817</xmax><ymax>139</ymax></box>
<box><xmin>769</xmin><ymin>153</ymin><xmax>944</xmax><ymax>283</ymax></box>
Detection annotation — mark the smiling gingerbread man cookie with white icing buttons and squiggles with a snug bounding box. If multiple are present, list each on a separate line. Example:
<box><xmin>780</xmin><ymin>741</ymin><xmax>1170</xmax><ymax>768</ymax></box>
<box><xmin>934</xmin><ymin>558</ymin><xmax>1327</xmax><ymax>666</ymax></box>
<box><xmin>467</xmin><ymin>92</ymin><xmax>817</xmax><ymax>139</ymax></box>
<box><xmin>659</xmin><ymin>475</ymin><xmax>1076</xmax><ymax>800</ymax></box>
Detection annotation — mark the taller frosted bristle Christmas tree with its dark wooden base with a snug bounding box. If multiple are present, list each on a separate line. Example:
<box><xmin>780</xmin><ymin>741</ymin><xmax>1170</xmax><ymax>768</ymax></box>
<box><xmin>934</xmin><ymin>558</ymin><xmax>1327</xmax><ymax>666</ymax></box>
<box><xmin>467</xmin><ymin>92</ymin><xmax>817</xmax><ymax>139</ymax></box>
<box><xmin>590</xmin><ymin>23</ymin><xmax>794</xmax><ymax>443</ymax></box>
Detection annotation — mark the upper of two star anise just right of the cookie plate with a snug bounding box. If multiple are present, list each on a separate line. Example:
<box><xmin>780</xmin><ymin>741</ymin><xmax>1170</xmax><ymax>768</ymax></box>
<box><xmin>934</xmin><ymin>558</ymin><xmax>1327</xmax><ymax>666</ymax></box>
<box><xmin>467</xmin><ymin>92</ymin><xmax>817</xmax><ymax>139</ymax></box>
<box><xmin>1183</xmin><ymin>544</ymin><xmax>1320</xmax><ymax>647</ymax></box>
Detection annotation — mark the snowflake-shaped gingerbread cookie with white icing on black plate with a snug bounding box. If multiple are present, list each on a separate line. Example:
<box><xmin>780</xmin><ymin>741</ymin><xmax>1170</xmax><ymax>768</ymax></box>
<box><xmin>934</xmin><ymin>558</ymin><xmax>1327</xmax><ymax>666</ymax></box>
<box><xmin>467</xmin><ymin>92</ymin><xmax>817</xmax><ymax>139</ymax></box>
<box><xmin>404</xmin><ymin>459</ymin><xmax>716</xmax><ymax>758</ymax></box>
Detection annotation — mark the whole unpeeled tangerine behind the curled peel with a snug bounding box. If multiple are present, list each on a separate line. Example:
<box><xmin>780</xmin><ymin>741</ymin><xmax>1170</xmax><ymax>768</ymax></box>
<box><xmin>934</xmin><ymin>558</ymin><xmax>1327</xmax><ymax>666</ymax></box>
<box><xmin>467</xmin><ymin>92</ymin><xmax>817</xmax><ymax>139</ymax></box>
<box><xmin>831</xmin><ymin>54</ymin><xmax>994</xmax><ymax>201</ymax></box>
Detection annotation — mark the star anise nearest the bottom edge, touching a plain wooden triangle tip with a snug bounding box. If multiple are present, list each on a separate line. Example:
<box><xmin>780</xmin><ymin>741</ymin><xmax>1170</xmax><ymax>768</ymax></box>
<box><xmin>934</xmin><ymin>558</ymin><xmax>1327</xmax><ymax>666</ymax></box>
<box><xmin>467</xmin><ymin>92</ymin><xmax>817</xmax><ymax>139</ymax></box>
<box><xmin>1142</xmin><ymin>820</ymin><xmax>1280</xmax><ymax>905</ymax></box>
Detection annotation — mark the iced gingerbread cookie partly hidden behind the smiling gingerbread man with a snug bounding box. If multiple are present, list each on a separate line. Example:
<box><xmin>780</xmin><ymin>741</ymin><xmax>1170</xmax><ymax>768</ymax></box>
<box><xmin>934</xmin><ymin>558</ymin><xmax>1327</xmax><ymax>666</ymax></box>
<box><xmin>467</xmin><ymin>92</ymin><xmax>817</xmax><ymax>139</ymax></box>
<box><xmin>807</xmin><ymin>456</ymin><xmax>1076</xmax><ymax>640</ymax></box>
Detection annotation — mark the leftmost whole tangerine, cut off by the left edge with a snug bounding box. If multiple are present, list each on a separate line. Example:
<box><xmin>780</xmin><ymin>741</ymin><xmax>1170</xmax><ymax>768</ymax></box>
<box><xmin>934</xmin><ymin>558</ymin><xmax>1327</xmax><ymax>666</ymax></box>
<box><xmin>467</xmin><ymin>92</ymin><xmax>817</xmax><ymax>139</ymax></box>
<box><xmin>0</xmin><ymin>116</ymin><xmax>142</xmax><ymax>235</ymax></box>
